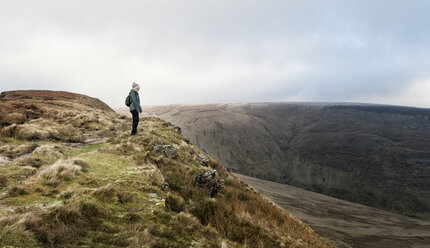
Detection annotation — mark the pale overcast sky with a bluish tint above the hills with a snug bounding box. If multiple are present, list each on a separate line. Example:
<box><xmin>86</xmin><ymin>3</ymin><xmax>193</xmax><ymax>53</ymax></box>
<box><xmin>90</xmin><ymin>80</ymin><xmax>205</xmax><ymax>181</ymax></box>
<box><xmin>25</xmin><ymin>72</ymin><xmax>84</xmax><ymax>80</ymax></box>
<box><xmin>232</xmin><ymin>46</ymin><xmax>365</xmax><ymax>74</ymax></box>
<box><xmin>0</xmin><ymin>0</ymin><xmax>430</xmax><ymax>108</ymax></box>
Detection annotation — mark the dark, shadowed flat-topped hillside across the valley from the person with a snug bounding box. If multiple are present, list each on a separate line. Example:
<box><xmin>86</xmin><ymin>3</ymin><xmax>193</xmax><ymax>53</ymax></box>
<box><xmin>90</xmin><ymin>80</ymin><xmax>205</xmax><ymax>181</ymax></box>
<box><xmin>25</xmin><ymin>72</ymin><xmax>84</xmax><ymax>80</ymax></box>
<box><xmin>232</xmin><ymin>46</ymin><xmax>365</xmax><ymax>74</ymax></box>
<box><xmin>122</xmin><ymin>103</ymin><xmax>430</xmax><ymax>217</ymax></box>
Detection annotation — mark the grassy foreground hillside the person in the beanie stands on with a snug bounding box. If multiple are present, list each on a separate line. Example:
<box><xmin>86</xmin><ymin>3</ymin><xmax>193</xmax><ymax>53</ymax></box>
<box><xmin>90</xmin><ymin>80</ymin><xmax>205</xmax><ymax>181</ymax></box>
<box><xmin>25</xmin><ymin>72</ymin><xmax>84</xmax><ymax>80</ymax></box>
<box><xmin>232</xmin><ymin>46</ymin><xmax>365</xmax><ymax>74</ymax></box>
<box><xmin>0</xmin><ymin>91</ymin><xmax>332</xmax><ymax>247</ymax></box>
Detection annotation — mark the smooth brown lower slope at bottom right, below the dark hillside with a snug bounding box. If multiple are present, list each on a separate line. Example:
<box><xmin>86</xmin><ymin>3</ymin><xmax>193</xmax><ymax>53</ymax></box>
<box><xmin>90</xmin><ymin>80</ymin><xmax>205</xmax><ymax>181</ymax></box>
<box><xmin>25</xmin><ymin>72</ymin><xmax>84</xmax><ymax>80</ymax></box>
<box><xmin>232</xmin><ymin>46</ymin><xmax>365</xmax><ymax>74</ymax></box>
<box><xmin>235</xmin><ymin>174</ymin><xmax>430</xmax><ymax>248</ymax></box>
